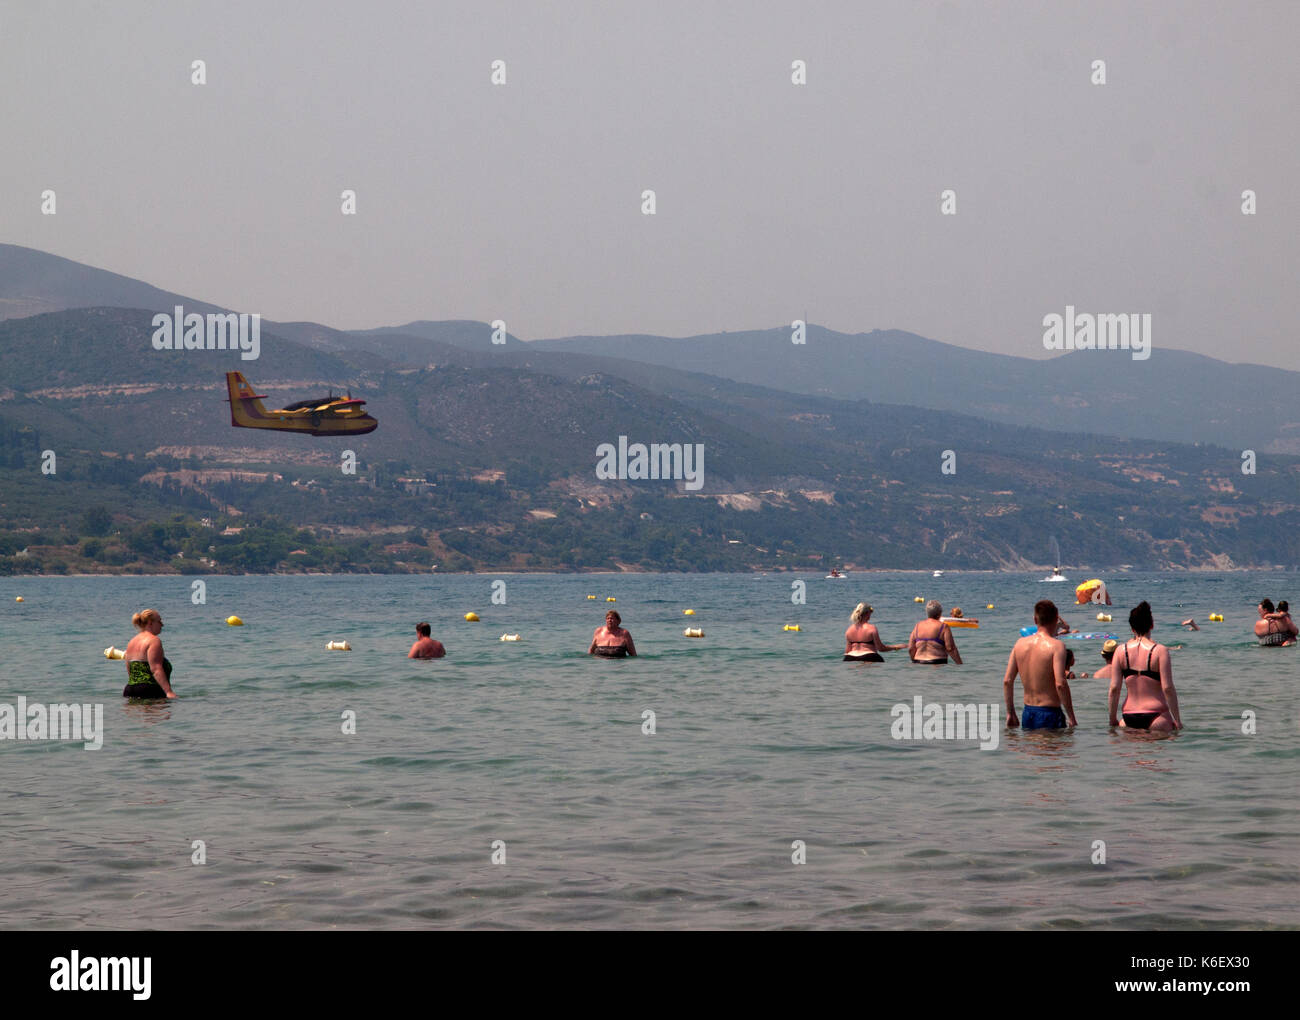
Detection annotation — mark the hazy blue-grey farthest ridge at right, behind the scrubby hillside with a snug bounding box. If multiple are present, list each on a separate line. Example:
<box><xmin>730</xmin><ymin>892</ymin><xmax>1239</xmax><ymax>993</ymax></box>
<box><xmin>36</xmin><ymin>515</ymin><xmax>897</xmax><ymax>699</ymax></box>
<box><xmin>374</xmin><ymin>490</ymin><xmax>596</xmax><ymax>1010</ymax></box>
<box><xmin>530</xmin><ymin>326</ymin><xmax>1300</xmax><ymax>453</ymax></box>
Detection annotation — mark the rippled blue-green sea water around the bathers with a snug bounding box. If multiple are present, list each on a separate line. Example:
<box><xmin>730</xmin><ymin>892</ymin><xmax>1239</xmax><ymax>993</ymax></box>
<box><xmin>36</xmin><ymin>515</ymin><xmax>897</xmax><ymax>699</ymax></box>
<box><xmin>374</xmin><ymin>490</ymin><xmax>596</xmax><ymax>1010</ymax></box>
<box><xmin>0</xmin><ymin>572</ymin><xmax>1300</xmax><ymax>929</ymax></box>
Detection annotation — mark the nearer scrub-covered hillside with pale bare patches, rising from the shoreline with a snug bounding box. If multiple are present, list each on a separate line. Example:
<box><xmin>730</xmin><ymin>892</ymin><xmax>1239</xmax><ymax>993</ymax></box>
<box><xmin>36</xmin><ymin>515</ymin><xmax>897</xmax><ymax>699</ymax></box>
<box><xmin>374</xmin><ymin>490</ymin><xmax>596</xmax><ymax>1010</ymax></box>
<box><xmin>0</xmin><ymin>308</ymin><xmax>1300</xmax><ymax>572</ymax></box>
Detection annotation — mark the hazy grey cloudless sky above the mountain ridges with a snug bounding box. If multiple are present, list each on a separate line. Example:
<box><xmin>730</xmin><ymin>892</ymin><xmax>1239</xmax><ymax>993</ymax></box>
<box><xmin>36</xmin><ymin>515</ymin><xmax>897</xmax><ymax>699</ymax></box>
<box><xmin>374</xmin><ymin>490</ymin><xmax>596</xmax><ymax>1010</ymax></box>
<box><xmin>0</xmin><ymin>0</ymin><xmax>1300</xmax><ymax>368</ymax></box>
